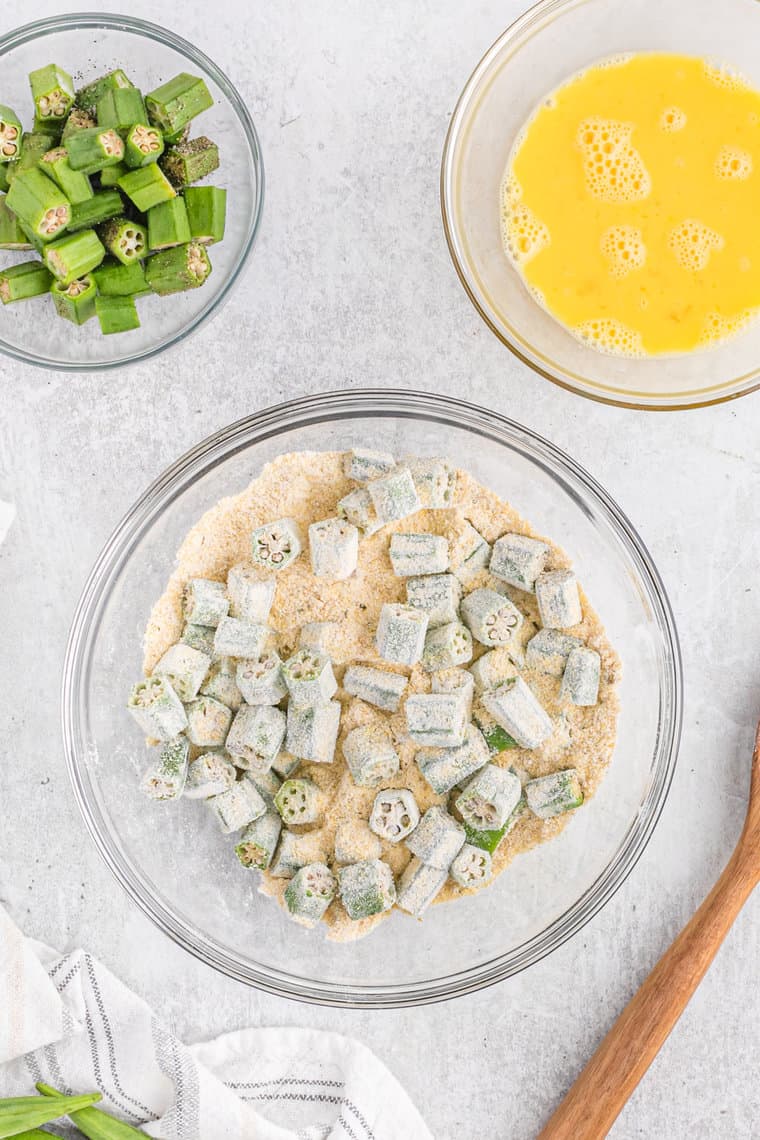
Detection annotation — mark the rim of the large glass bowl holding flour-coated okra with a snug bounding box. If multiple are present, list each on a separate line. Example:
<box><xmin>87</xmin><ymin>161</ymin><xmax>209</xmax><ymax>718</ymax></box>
<box><xmin>62</xmin><ymin>389</ymin><xmax>683</xmax><ymax>1008</ymax></box>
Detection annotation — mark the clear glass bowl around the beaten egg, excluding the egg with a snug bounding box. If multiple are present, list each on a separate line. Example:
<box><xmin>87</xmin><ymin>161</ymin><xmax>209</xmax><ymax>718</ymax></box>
<box><xmin>441</xmin><ymin>0</ymin><xmax>760</xmax><ymax>409</ymax></box>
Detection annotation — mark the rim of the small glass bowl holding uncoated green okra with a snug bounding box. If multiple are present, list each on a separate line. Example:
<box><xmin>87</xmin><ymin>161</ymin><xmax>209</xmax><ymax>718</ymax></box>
<box><xmin>0</xmin><ymin>11</ymin><xmax>265</xmax><ymax>373</ymax></box>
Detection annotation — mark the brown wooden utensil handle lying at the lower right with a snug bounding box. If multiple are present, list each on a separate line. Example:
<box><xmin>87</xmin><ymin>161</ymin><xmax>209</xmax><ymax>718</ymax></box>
<box><xmin>538</xmin><ymin>724</ymin><xmax>760</xmax><ymax>1140</ymax></box>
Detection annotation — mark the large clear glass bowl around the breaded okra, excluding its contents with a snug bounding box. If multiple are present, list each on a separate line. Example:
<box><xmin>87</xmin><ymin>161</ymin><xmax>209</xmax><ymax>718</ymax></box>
<box><xmin>63</xmin><ymin>390</ymin><xmax>681</xmax><ymax>1007</ymax></box>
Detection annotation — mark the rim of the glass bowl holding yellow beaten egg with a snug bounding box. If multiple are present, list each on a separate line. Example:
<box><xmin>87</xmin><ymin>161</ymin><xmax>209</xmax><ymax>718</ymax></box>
<box><xmin>439</xmin><ymin>0</ymin><xmax>760</xmax><ymax>412</ymax></box>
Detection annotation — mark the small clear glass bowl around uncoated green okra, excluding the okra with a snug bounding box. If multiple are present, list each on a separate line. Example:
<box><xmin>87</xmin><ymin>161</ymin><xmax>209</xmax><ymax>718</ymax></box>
<box><xmin>0</xmin><ymin>13</ymin><xmax>264</xmax><ymax>372</ymax></box>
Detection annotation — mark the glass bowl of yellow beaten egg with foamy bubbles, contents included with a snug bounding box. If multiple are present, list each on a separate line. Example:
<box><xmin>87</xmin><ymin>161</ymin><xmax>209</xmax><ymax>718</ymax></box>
<box><xmin>441</xmin><ymin>0</ymin><xmax>760</xmax><ymax>409</ymax></box>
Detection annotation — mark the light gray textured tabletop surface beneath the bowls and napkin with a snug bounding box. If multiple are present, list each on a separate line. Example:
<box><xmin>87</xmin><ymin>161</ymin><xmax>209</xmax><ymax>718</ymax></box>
<box><xmin>0</xmin><ymin>0</ymin><xmax>760</xmax><ymax>1140</ymax></box>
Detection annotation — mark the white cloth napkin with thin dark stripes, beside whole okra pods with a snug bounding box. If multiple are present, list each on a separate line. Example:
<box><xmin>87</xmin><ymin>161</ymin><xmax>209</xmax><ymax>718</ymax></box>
<box><xmin>0</xmin><ymin>906</ymin><xmax>433</xmax><ymax>1140</ymax></box>
